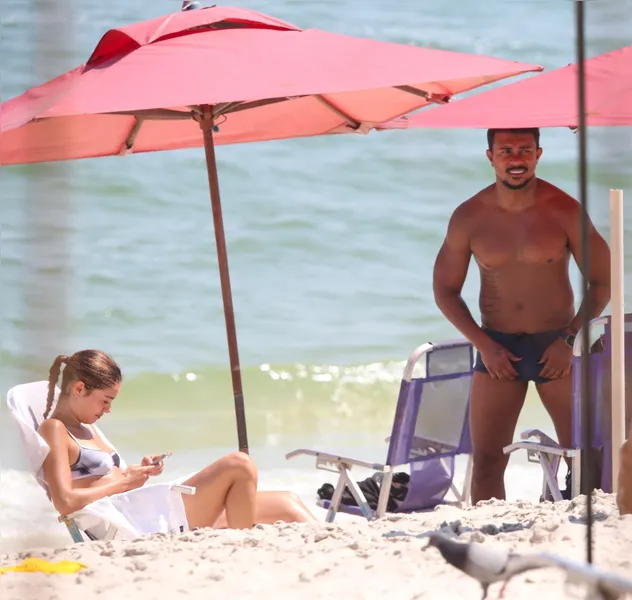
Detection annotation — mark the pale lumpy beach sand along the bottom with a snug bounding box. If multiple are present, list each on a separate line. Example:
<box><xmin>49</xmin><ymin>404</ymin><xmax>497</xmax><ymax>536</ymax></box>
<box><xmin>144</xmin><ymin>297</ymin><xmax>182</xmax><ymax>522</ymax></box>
<box><xmin>0</xmin><ymin>492</ymin><xmax>632</xmax><ymax>600</ymax></box>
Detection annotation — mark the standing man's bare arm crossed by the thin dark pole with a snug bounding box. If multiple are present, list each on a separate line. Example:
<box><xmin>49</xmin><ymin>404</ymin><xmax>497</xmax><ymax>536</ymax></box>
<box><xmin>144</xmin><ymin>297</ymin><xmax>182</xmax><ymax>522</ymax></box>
<box><xmin>566</xmin><ymin>202</ymin><xmax>610</xmax><ymax>334</ymax></box>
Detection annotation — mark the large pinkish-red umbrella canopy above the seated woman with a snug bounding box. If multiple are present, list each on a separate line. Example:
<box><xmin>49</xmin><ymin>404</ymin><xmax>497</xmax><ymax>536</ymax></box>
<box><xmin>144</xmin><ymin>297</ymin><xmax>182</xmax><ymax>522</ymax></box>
<box><xmin>0</xmin><ymin>6</ymin><xmax>542</xmax><ymax>165</ymax></box>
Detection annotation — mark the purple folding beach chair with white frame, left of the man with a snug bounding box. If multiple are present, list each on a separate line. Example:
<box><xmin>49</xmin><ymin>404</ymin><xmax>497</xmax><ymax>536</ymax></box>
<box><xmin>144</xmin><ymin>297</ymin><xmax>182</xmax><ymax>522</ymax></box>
<box><xmin>286</xmin><ymin>340</ymin><xmax>474</xmax><ymax>522</ymax></box>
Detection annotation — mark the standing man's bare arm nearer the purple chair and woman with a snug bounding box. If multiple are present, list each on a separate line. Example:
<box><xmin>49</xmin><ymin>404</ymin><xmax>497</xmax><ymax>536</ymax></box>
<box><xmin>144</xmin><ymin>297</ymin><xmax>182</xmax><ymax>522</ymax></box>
<box><xmin>432</xmin><ymin>205</ymin><xmax>490</xmax><ymax>349</ymax></box>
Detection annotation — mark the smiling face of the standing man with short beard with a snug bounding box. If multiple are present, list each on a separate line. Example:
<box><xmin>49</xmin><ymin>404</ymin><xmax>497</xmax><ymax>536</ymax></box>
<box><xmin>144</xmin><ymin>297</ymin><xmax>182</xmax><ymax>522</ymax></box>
<box><xmin>487</xmin><ymin>132</ymin><xmax>542</xmax><ymax>190</ymax></box>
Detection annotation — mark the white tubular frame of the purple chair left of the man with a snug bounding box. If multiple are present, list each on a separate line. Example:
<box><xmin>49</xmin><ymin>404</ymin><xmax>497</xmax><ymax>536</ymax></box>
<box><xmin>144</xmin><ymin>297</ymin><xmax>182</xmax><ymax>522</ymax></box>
<box><xmin>285</xmin><ymin>340</ymin><xmax>474</xmax><ymax>522</ymax></box>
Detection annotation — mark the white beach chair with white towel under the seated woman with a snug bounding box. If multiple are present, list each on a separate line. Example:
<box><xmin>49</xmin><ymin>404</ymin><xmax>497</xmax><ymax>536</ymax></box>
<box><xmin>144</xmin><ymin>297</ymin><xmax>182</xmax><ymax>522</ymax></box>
<box><xmin>7</xmin><ymin>381</ymin><xmax>195</xmax><ymax>542</ymax></box>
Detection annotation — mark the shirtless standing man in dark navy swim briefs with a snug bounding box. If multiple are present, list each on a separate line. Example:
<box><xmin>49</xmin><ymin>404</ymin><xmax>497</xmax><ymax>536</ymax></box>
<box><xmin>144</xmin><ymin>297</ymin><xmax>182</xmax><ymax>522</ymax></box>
<box><xmin>433</xmin><ymin>129</ymin><xmax>610</xmax><ymax>503</ymax></box>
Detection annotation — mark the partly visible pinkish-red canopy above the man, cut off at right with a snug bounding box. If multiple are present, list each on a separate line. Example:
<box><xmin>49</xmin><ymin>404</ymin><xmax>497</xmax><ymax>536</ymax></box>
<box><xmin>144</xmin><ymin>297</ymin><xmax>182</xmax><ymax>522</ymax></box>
<box><xmin>399</xmin><ymin>46</ymin><xmax>632</xmax><ymax>129</ymax></box>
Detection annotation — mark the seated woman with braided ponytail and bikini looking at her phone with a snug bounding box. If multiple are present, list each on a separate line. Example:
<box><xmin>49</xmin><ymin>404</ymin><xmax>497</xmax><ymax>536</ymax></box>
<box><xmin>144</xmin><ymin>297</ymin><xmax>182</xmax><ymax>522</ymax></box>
<box><xmin>38</xmin><ymin>350</ymin><xmax>315</xmax><ymax>529</ymax></box>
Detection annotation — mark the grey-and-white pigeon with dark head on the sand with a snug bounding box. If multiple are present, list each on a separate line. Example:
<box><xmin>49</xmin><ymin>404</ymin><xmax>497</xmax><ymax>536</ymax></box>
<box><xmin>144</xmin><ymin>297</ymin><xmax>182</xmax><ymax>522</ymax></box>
<box><xmin>424</xmin><ymin>532</ymin><xmax>550</xmax><ymax>600</ymax></box>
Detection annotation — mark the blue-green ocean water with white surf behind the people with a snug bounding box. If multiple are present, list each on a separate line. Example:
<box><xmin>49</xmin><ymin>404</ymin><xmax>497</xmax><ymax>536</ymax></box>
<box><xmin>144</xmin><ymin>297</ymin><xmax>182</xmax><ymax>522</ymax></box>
<box><xmin>0</xmin><ymin>0</ymin><xmax>632</xmax><ymax>549</ymax></box>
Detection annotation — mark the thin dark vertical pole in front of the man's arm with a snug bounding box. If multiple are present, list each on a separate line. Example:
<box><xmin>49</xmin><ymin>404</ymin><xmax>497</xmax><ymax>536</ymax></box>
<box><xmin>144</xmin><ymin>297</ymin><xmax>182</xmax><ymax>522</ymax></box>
<box><xmin>575</xmin><ymin>0</ymin><xmax>593</xmax><ymax>564</ymax></box>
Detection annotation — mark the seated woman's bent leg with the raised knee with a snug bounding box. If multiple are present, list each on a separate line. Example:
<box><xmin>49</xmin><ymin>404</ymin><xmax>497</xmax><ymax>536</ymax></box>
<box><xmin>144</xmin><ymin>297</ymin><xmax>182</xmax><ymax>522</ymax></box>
<box><xmin>182</xmin><ymin>452</ymin><xmax>258</xmax><ymax>529</ymax></box>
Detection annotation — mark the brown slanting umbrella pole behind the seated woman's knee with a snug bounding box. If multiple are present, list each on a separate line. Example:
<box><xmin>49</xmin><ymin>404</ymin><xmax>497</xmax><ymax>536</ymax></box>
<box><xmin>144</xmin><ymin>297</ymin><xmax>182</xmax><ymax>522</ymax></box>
<box><xmin>198</xmin><ymin>106</ymin><xmax>248</xmax><ymax>454</ymax></box>
